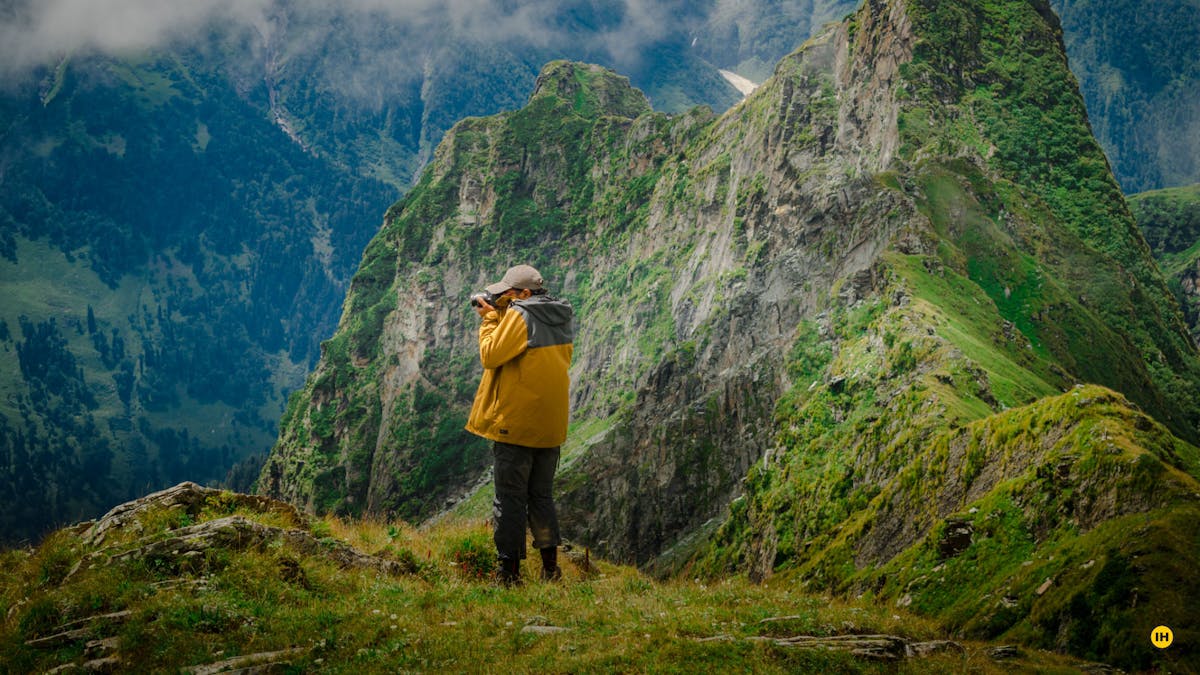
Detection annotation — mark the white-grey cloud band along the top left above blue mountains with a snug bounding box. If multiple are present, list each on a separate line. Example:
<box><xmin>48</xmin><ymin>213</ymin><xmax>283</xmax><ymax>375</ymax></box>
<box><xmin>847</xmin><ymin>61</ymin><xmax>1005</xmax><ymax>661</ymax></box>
<box><xmin>0</xmin><ymin>0</ymin><xmax>688</xmax><ymax>74</ymax></box>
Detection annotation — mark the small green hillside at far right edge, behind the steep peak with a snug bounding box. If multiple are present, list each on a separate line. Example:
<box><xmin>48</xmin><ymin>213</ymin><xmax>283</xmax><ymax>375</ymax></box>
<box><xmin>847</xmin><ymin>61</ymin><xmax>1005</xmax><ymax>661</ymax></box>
<box><xmin>1129</xmin><ymin>185</ymin><xmax>1200</xmax><ymax>345</ymax></box>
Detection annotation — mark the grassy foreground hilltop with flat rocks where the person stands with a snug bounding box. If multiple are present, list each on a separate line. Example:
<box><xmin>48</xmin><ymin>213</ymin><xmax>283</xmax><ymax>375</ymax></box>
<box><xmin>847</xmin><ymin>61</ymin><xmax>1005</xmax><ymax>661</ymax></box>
<box><xmin>0</xmin><ymin>484</ymin><xmax>1104</xmax><ymax>673</ymax></box>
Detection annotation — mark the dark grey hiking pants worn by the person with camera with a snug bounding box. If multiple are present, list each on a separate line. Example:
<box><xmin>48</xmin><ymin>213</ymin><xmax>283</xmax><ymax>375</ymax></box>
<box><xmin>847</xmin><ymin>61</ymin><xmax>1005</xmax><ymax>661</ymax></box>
<box><xmin>492</xmin><ymin>441</ymin><xmax>560</xmax><ymax>558</ymax></box>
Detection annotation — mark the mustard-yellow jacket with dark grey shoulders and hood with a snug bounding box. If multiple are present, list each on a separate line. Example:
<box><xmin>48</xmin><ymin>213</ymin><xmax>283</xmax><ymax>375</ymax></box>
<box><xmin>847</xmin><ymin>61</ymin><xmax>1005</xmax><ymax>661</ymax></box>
<box><xmin>467</xmin><ymin>295</ymin><xmax>575</xmax><ymax>448</ymax></box>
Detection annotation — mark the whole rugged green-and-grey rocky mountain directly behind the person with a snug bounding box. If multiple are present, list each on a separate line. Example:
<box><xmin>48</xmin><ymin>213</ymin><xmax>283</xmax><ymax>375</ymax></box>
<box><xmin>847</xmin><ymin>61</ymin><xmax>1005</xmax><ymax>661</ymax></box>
<box><xmin>259</xmin><ymin>0</ymin><xmax>1200</xmax><ymax>668</ymax></box>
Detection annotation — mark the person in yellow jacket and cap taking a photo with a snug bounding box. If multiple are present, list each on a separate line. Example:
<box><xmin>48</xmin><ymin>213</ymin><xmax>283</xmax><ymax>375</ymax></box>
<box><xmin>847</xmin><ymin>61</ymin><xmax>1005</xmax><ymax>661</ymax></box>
<box><xmin>467</xmin><ymin>265</ymin><xmax>575</xmax><ymax>585</ymax></box>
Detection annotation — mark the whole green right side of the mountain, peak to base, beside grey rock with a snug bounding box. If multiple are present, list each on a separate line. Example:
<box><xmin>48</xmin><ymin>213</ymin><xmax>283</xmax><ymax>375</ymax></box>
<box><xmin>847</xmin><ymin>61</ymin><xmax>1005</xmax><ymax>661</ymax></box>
<box><xmin>695</xmin><ymin>1</ymin><xmax>1200</xmax><ymax>668</ymax></box>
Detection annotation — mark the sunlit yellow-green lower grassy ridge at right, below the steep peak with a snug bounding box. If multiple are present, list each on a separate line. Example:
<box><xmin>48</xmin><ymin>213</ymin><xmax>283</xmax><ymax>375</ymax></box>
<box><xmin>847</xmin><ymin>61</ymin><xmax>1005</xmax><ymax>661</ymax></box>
<box><xmin>692</xmin><ymin>247</ymin><xmax>1200</xmax><ymax>668</ymax></box>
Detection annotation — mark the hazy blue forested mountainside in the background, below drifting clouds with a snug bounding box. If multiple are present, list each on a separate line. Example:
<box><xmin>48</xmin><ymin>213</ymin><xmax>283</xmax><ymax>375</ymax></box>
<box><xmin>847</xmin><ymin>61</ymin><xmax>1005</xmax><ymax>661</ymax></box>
<box><xmin>0</xmin><ymin>1</ymin><xmax>799</xmax><ymax>543</ymax></box>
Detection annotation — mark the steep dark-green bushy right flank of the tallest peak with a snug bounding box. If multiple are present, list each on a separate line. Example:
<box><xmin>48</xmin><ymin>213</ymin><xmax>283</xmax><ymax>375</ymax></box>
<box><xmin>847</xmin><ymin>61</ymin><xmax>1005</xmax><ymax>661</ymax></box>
<box><xmin>899</xmin><ymin>0</ymin><xmax>1200</xmax><ymax>441</ymax></box>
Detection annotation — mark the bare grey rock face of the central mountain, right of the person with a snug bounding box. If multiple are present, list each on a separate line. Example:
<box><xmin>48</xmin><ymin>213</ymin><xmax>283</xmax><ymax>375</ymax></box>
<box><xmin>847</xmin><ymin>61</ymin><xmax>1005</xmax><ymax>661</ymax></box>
<box><xmin>562</xmin><ymin>9</ymin><xmax>912</xmax><ymax>562</ymax></box>
